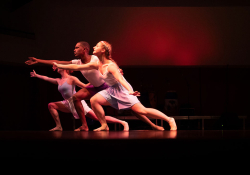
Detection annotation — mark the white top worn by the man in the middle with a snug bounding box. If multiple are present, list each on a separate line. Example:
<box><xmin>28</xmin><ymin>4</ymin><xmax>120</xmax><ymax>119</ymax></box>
<box><xmin>72</xmin><ymin>55</ymin><xmax>105</xmax><ymax>87</ymax></box>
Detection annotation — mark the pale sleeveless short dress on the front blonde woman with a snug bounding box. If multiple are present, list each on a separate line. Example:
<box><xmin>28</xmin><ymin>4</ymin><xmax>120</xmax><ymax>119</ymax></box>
<box><xmin>98</xmin><ymin>63</ymin><xmax>140</xmax><ymax>110</ymax></box>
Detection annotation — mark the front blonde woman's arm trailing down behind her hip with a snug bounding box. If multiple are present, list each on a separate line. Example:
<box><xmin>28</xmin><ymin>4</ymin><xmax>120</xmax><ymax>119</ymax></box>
<box><xmin>108</xmin><ymin>64</ymin><xmax>140</xmax><ymax>96</ymax></box>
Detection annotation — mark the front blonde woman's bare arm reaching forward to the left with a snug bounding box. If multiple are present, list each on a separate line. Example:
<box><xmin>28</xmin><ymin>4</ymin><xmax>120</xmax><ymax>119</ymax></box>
<box><xmin>54</xmin><ymin>62</ymin><xmax>98</xmax><ymax>71</ymax></box>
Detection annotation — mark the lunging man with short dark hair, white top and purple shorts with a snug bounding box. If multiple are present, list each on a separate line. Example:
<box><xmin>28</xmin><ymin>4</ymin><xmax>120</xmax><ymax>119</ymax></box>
<box><xmin>25</xmin><ymin>41</ymin><xmax>164</xmax><ymax>131</ymax></box>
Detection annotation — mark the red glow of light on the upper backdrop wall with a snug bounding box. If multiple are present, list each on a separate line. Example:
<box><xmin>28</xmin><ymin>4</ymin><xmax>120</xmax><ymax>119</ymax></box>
<box><xmin>114</xmin><ymin>7</ymin><xmax>218</xmax><ymax>65</ymax></box>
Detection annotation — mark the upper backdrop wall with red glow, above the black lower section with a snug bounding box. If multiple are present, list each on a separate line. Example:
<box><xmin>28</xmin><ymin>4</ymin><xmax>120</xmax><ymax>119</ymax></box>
<box><xmin>0</xmin><ymin>0</ymin><xmax>250</xmax><ymax>66</ymax></box>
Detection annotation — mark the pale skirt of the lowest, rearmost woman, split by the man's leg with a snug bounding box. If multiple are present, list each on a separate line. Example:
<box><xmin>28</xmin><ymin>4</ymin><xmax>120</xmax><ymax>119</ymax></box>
<box><xmin>61</xmin><ymin>98</ymin><xmax>92</xmax><ymax>119</ymax></box>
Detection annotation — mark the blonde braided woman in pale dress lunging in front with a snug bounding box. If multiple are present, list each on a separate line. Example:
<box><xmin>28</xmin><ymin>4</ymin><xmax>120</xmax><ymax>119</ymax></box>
<box><xmin>54</xmin><ymin>41</ymin><xmax>177</xmax><ymax>131</ymax></box>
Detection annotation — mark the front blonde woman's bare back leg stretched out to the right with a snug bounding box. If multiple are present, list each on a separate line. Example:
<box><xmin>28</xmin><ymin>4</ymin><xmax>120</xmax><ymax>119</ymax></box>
<box><xmin>131</xmin><ymin>103</ymin><xmax>177</xmax><ymax>130</ymax></box>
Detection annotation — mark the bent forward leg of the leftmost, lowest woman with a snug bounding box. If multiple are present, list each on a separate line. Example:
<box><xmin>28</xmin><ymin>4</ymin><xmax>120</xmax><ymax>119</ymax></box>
<box><xmin>48</xmin><ymin>102</ymin><xmax>70</xmax><ymax>131</ymax></box>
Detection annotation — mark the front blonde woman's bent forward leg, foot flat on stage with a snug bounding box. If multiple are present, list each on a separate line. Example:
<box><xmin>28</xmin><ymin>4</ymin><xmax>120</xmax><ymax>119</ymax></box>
<box><xmin>90</xmin><ymin>94</ymin><xmax>110</xmax><ymax>131</ymax></box>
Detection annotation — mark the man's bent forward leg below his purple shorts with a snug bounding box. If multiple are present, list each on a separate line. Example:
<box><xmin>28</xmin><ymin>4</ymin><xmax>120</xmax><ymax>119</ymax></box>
<box><xmin>72</xmin><ymin>88</ymin><xmax>91</xmax><ymax>131</ymax></box>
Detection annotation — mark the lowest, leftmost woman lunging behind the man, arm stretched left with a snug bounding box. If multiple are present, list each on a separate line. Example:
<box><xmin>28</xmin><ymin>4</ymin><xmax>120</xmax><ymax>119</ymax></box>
<box><xmin>30</xmin><ymin>69</ymin><xmax>129</xmax><ymax>131</ymax></box>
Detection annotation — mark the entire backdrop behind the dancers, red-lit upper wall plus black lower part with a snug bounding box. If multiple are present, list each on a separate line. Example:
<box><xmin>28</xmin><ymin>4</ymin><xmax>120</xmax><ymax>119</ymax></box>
<box><xmin>0</xmin><ymin>0</ymin><xmax>250</xmax><ymax>130</ymax></box>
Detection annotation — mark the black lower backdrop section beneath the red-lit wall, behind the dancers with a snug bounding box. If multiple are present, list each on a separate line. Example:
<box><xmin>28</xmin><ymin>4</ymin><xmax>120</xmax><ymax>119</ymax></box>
<box><xmin>0</xmin><ymin>64</ymin><xmax>250</xmax><ymax>130</ymax></box>
